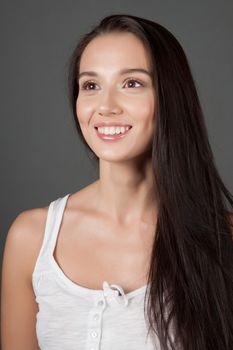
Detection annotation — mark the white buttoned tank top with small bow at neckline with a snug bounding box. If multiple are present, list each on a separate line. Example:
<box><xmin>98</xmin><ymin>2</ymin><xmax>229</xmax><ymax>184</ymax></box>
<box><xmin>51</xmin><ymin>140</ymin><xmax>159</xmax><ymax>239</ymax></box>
<box><xmin>32</xmin><ymin>194</ymin><xmax>160</xmax><ymax>350</ymax></box>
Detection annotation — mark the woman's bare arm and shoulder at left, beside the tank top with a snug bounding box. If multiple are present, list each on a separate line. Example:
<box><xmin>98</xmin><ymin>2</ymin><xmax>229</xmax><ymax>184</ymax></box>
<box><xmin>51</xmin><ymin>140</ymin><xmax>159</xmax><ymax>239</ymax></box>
<box><xmin>1</xmin><ymin>208</ymin><xmax>45</xmax><ymax>350</ymax></box>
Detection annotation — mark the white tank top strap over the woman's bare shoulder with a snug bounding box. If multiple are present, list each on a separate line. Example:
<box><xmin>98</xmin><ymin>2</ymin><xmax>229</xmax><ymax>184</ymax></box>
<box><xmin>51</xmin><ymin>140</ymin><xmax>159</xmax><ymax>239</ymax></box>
<box><xmin>33</xmin><ymin>193</ymin><xmax>70</xmax><ymax>273</ymax></box>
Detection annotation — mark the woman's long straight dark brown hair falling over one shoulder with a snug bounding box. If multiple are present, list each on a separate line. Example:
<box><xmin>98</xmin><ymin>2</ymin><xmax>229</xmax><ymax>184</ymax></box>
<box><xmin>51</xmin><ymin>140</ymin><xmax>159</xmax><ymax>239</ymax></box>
<box><xmin>69</xmin><ymin>14</ymin><xmax>233</xmax><ymax>350</ymax></box>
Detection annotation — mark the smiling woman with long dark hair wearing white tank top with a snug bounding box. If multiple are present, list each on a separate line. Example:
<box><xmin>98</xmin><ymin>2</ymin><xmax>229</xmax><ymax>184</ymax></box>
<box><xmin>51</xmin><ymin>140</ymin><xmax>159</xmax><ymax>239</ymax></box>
<box><xmin>2</xmin><ymin>15</ymin><xmax>233</xmax><ymax>350</ymax></box>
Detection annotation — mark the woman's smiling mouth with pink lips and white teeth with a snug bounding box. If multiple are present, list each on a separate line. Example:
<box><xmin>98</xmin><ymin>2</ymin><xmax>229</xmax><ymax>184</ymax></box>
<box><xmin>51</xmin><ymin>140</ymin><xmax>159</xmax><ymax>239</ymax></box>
<box><xmin>95</xmin><ymin>126</ymin><xmax>132</xmax><ymax>141</ymax></box>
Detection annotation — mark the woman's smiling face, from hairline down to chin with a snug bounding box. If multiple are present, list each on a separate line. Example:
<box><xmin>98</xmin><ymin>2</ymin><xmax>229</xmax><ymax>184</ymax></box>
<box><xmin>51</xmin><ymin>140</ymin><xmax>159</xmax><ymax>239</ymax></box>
<box><xmin>76</xmin><ymin>33</ymin><xmax>156</xmax><ymax>161</ymax></box>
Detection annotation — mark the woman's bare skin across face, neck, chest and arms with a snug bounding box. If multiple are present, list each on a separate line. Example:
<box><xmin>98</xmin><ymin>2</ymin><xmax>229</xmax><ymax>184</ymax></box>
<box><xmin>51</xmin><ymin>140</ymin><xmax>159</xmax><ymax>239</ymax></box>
<box><xmin>1</xmin><ymin>33</ymin><xmax>233</xmax><ymax>350</ymax></box>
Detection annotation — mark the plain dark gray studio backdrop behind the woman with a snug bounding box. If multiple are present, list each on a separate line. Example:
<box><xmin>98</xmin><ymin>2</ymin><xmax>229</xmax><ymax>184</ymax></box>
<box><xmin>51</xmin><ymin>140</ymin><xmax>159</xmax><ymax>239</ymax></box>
<box><xmin>0</xmin><ymin>0</ymin><xmax>233</xmax><ymax>270</ymax></box>
